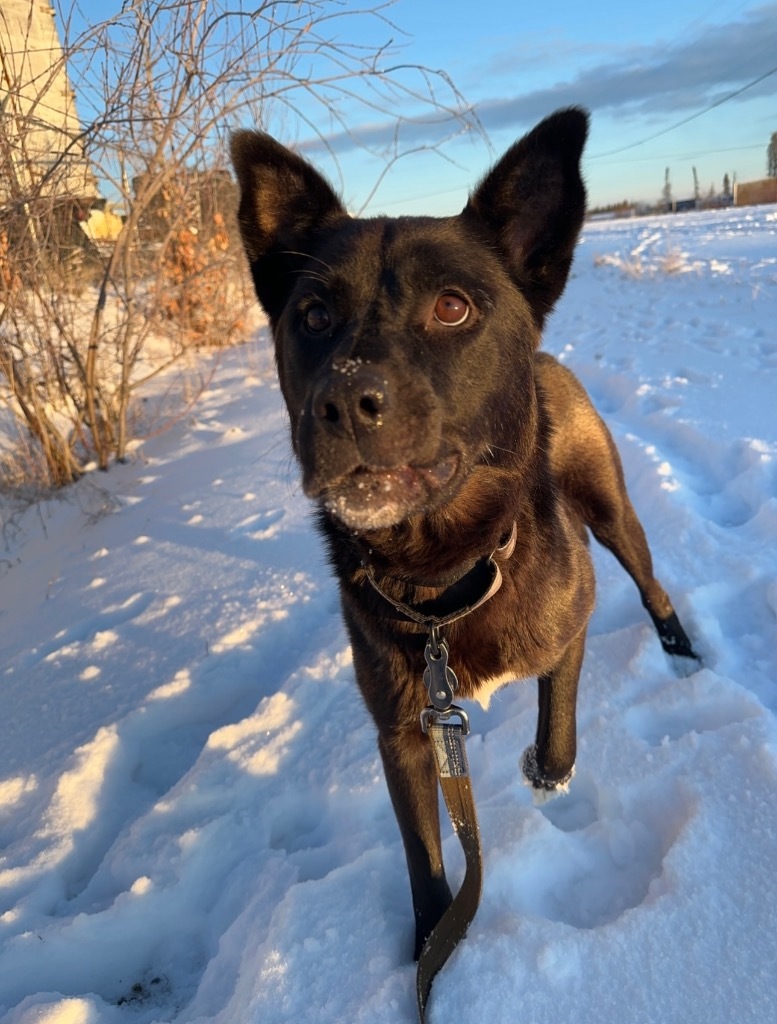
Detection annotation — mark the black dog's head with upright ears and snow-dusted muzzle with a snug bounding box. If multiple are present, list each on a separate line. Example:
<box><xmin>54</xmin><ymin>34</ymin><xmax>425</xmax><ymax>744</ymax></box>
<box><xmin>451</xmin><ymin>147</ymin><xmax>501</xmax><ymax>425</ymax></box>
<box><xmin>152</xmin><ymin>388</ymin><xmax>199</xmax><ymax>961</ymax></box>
<box><xmin>232</xmin><ymin>108</ymin><xmax>588</xmax><ymax>532</ymax></box>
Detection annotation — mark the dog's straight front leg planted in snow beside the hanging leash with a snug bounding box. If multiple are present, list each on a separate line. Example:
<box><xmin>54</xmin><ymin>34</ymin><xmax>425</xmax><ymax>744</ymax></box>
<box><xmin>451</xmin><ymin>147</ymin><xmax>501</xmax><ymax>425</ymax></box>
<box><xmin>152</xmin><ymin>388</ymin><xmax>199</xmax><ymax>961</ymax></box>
<box><xmin>378</xmin><ymin>724</ymin><xmax>452</xmax><ymax>959</ymax></box>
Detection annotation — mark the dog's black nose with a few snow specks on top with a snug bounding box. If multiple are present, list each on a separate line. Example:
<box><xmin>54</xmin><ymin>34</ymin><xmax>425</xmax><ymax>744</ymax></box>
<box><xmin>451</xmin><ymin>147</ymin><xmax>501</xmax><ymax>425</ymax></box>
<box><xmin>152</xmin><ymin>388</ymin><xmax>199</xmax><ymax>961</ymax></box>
<box><xmin>313</xmin><ymin>362</ymin><xmax>388</xmax><ymax>434</ymax></box>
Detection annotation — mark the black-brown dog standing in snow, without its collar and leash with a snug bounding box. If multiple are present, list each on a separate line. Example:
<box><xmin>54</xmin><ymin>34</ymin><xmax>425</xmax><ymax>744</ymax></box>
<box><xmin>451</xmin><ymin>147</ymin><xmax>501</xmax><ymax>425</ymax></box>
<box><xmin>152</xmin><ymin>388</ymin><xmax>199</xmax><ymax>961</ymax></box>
<box><xmin>232</xmin><ymin>109</ymin><xmax>695</xmax><ymax>955</ymax></box>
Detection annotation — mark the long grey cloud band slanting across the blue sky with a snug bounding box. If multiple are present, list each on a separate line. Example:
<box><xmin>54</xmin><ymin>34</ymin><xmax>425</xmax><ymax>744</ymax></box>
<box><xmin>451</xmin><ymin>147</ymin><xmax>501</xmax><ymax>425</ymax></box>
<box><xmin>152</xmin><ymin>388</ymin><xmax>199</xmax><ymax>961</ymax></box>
<box><xmin>303</xmin><ymin>3</ymin><xmax>777</xmax><ymax>153</ymax></box>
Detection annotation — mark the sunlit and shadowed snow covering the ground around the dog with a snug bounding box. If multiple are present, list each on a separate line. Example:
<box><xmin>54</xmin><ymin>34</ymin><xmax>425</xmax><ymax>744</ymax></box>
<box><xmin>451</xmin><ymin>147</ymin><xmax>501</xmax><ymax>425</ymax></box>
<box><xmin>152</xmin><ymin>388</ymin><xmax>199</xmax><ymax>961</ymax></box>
<box><xmin>0</xmin><ymin>207</ymin><xmax>777</xmax><ymax>1024</ymax></box>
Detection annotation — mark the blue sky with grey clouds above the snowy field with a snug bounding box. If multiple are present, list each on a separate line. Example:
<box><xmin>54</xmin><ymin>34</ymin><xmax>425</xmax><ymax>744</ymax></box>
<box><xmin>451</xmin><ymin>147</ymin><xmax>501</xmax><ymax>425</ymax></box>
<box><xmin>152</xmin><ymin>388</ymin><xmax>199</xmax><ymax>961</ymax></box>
<box><xmin>65</xmin><ymin>0</ymin><xmax>777</xmax><ymax>214</ymax></box>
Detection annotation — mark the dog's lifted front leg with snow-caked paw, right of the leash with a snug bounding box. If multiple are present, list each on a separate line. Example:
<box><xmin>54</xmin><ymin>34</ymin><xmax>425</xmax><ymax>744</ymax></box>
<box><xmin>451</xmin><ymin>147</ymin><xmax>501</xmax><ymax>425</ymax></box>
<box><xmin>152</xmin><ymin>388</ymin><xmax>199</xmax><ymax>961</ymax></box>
<box><xmin>521</xmin><ymin>630</ymin><xmax>586</xmax><ymax>801</ymax></box>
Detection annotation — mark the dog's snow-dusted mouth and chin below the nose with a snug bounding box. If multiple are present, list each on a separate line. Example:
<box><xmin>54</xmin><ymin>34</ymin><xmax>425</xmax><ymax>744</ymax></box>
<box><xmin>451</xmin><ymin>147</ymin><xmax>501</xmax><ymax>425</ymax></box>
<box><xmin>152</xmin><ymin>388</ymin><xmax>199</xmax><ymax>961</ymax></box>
<box><xmin>309</xmin><ymin>455</ymin><xmax>461</xmax><ymax>532</ymax></box>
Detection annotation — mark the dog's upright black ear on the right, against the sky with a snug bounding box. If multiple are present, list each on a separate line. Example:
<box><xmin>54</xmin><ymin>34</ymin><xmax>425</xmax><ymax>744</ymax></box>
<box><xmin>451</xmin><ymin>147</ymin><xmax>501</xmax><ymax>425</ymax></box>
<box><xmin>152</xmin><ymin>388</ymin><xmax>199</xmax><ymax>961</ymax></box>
<box><xmin>462</xmin><ymin>106</ymin><xmax>589</xmax><ymax>327</ymax></box>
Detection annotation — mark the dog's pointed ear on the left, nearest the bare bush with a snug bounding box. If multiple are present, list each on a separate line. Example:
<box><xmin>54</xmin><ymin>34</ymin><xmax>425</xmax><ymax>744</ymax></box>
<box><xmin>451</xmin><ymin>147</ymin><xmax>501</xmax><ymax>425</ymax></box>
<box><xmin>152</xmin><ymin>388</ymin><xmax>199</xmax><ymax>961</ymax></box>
<box><xmin>230</xmin><ymin>131</ymin><xmax>347</xmax><ymax>324</ymax></box>
